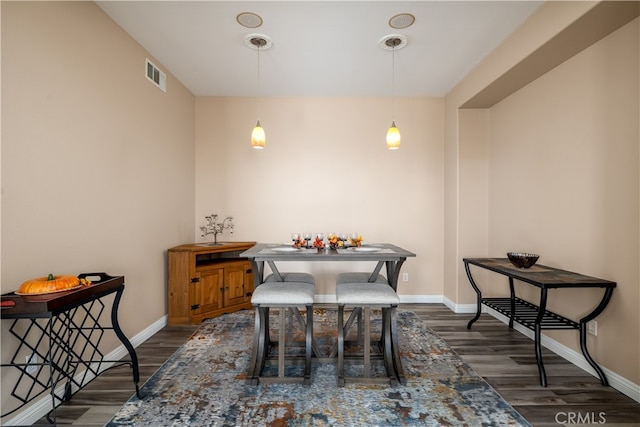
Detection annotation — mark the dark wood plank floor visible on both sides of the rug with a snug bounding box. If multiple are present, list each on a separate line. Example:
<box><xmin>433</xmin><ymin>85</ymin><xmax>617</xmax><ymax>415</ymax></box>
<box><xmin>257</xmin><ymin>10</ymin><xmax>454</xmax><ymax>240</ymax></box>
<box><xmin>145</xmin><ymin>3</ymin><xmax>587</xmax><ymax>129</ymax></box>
<box><xmin>34</xmin><ymin>304</ymin><xmax>640</xmax><ymax>427</ymax></box>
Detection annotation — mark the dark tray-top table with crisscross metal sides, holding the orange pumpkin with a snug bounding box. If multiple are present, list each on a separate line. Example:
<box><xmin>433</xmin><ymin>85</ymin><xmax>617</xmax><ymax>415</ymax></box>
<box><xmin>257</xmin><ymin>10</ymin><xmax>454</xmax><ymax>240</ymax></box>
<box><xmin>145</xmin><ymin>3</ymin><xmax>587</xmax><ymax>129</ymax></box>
<box><xmin>0</xmin><ymin>273</ymin><xmax>140</xmax><ymax>424</ymax></box>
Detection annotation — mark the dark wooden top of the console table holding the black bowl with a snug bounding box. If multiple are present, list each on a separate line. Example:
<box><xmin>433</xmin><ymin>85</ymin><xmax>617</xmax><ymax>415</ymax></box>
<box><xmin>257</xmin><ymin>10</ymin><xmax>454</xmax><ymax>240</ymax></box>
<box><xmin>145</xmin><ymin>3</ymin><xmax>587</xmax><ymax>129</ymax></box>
<box><xmin>463</xmin><ymin>258</ymin><xmax>616</xmax><ymax>288</ymax></box>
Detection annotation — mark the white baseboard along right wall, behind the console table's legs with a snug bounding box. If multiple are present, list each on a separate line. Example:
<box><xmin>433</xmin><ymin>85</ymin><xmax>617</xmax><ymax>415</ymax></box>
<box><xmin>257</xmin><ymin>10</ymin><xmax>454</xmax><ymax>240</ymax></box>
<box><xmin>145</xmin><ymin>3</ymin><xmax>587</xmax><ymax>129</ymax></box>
<box><xmin>484</xmin><ymin>305</ymin><xmax>640</xmax><ymax>402</ymax></box>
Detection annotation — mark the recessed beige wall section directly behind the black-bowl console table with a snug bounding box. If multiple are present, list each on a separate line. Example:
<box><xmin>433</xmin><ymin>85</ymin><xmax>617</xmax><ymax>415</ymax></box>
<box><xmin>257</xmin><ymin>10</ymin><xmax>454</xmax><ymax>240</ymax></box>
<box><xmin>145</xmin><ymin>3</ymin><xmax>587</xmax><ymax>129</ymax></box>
<box><xmin>489</xmin><ymin>20</ymin><xmax>640</xmax><ymax>383</ymax></box>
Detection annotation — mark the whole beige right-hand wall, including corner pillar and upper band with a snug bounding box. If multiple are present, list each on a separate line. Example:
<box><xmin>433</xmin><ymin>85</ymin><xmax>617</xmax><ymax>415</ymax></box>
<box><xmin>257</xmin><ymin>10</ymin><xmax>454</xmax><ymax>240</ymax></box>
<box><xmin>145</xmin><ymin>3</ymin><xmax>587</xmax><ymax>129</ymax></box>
<box><xmin>444</xmin><ymin>2</ymin><xmax>640</xmax><ymax>384</ymax></box>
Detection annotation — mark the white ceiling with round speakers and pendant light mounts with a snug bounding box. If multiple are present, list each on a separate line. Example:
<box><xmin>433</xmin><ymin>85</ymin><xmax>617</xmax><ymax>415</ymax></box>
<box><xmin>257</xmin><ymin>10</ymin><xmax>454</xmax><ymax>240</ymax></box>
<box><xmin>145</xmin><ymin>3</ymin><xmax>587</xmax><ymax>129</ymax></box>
<box><xmin>97</xmin><ymin>0</ymin><xmax>542</xmax><ymax>96</ymax></box>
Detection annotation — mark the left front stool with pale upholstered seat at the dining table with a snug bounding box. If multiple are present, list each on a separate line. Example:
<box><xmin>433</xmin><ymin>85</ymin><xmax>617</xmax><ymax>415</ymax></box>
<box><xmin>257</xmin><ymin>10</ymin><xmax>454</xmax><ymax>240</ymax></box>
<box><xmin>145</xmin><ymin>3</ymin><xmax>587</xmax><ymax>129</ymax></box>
<box><xmin>248</xmin><ymin>281</ymin><xmax>315</xmax><ymax>385</ymax></box>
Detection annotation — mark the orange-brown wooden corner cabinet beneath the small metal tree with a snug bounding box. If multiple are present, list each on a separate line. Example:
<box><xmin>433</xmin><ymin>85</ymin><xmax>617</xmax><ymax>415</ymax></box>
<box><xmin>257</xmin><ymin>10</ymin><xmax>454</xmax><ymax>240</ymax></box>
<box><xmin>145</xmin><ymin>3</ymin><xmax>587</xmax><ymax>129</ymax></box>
<box><xmin>168</xmin><ymin>242</ymin><xmax>255</xmax><ymax>325</ymax></box>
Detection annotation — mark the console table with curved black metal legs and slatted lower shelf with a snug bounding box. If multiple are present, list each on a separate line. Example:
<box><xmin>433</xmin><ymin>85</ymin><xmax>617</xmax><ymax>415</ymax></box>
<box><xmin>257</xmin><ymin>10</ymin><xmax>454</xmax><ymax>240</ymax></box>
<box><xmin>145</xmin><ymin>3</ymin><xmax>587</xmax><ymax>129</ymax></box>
<box><xmin>463</xmin><ymin>258</ymin><xmax>616</xmax><ymax>387</ymax></box>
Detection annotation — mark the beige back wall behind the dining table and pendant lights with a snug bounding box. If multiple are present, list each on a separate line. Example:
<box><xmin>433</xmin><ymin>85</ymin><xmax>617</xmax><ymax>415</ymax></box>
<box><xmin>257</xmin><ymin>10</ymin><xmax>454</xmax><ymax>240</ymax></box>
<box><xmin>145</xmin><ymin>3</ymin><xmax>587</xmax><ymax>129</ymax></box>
<box><xmin>196</xmin><ymin>97</ymin><xmax>444</xmax><ymax>297</ymax></box>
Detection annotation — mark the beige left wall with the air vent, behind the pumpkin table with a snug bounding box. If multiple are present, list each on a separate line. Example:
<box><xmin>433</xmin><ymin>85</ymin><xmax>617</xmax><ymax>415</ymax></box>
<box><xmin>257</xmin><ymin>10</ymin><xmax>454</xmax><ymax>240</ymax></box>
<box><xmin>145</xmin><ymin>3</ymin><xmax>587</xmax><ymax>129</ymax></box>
<box><xmin>1</xmin><ymin>1</ymin><xmax>195</xmax><ymax>418</ymax></box>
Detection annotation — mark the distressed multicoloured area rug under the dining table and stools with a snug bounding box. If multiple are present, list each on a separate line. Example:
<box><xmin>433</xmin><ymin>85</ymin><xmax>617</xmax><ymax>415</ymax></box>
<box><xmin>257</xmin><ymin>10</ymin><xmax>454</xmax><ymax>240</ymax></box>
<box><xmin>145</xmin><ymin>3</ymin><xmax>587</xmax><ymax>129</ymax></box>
<box><xmin>107</xmin><ymin>309</ymin><xmax>529</xmax><ymax>427</ymax></box>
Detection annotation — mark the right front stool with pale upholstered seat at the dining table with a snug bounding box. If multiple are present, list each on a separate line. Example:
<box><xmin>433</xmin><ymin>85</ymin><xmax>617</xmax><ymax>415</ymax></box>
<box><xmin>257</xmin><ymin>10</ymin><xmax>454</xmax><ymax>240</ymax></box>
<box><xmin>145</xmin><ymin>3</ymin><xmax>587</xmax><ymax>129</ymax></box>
<box><xmin>336</xmin><ymin>280</ymin><xmax>404</xmax><ymax>386</ymax></box>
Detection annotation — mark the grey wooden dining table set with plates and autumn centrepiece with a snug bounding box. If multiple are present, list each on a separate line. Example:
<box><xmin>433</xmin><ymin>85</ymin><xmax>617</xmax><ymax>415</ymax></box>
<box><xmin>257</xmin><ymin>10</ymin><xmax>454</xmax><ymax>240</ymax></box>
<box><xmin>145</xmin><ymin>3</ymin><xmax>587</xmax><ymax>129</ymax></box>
<box><xmin>240</xmin><ymin>243</ymin><xmax>416</xmax><ymax>384</ymax></box>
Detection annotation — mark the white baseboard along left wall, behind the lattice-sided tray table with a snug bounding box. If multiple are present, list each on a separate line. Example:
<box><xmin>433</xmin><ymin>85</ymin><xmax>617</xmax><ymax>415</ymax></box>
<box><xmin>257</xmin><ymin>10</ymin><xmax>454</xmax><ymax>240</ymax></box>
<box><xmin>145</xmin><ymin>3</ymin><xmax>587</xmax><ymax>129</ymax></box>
<box><xmin>2</xmin><ymin>315</ymin><xmax>167</xmax><ymax>426</ymax></box>
